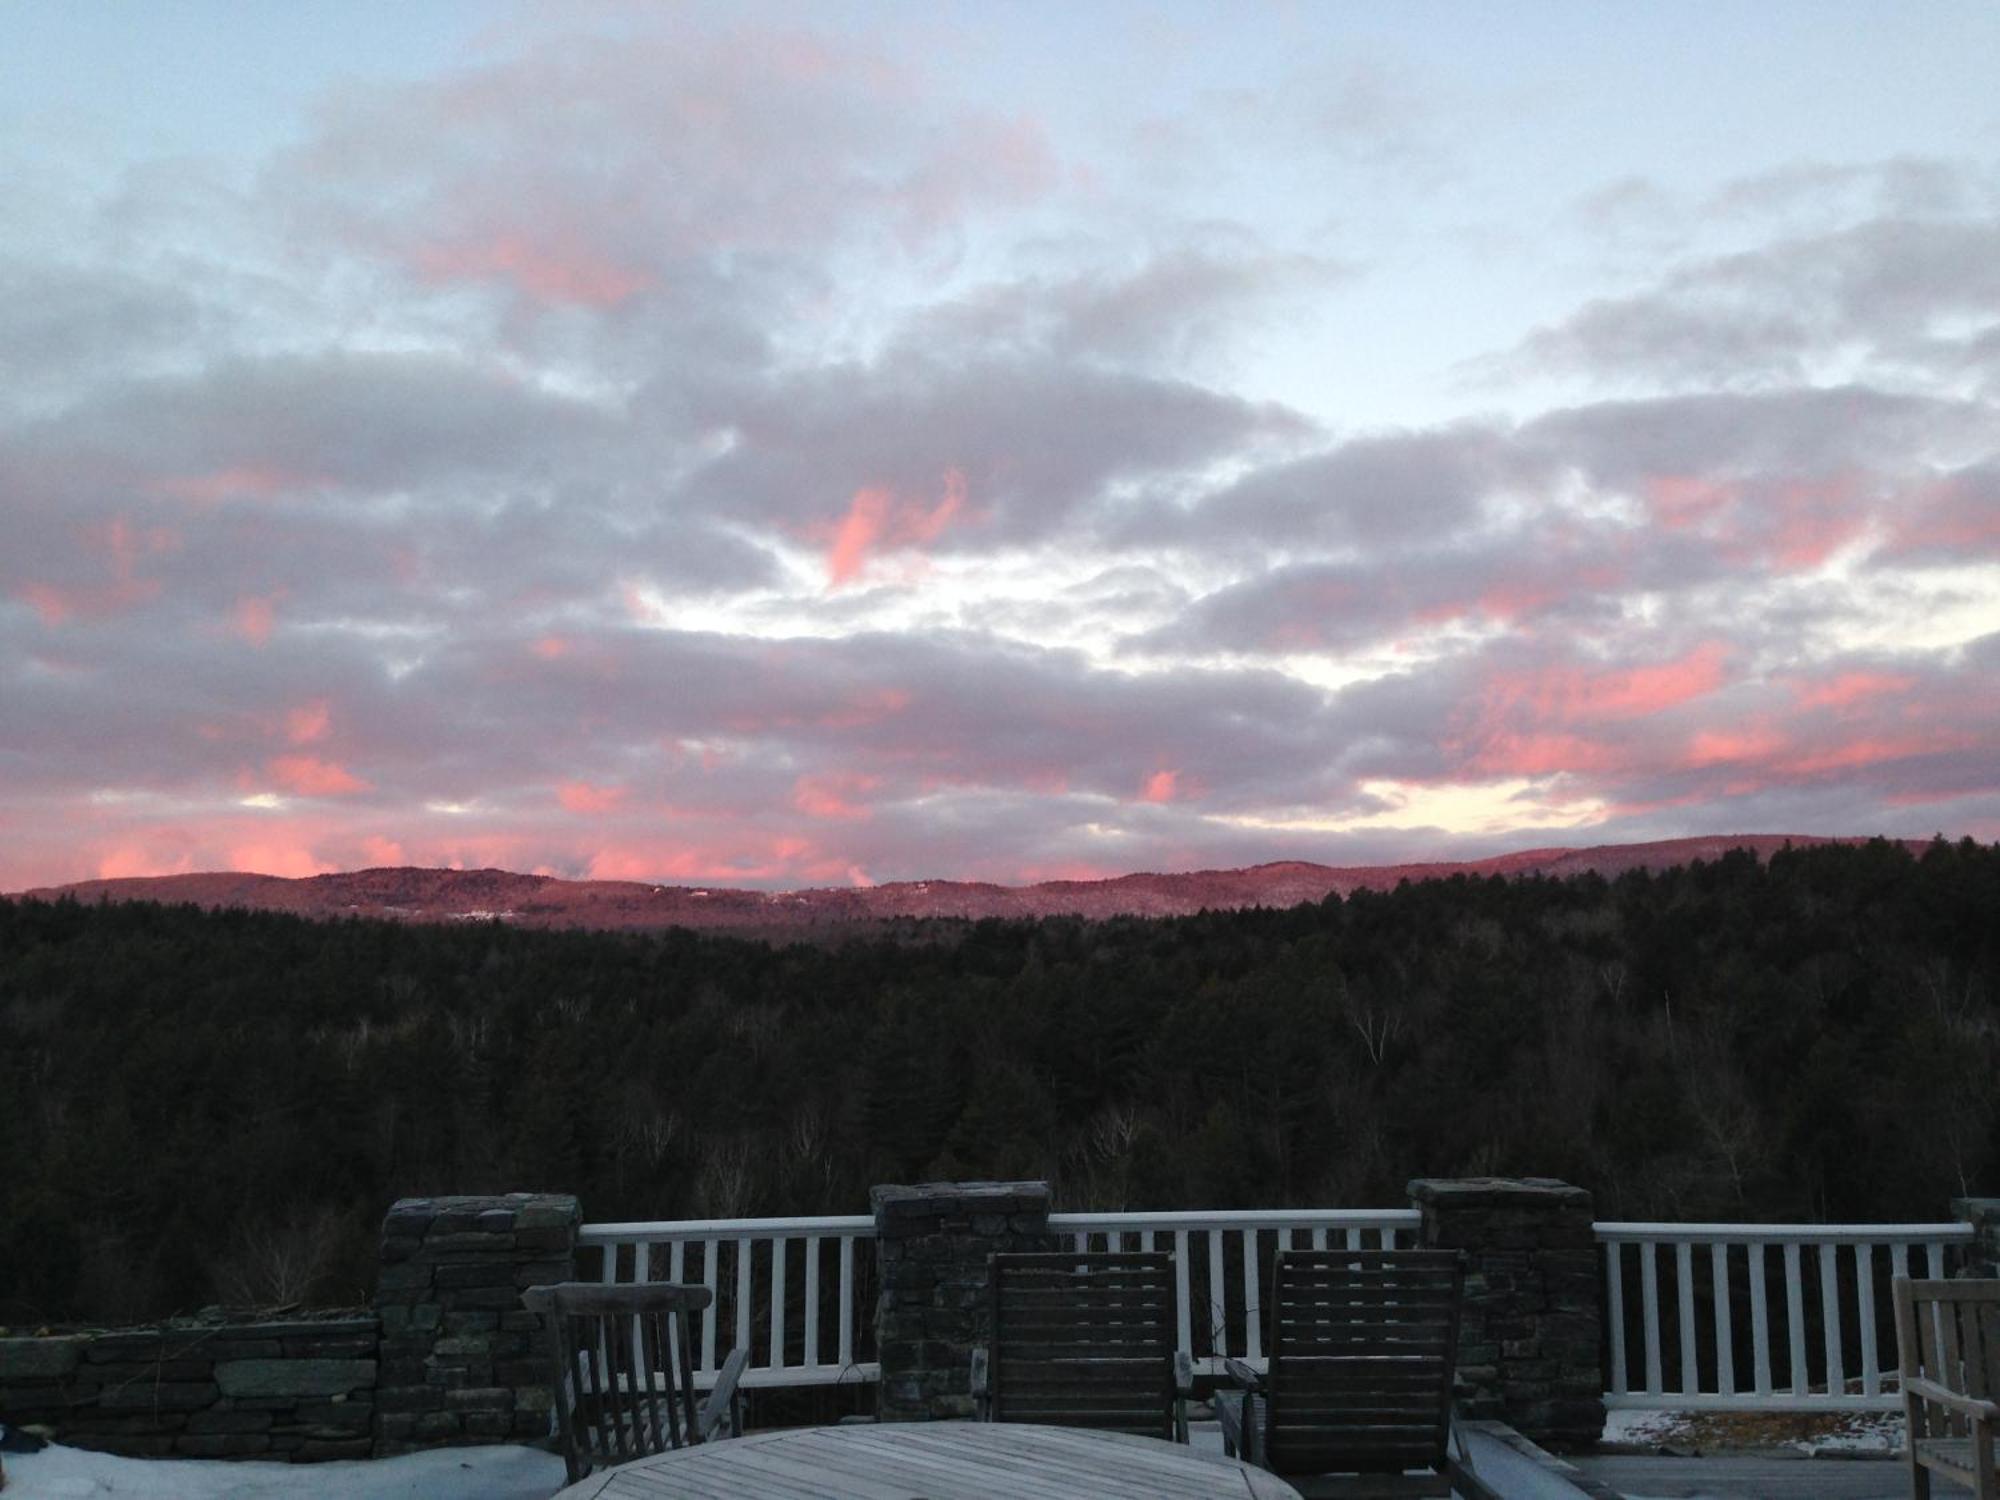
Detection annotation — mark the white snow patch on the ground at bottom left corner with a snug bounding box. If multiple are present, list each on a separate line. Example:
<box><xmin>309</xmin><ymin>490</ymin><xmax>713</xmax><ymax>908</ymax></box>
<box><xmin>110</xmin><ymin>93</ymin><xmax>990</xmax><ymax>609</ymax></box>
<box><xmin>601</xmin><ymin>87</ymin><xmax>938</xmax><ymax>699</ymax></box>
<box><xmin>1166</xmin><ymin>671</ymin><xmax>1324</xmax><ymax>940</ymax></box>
<box><xmin>4</xmin><ymin>1446</ymin><xmax>564</xmax><ymax>1500</ymax></box>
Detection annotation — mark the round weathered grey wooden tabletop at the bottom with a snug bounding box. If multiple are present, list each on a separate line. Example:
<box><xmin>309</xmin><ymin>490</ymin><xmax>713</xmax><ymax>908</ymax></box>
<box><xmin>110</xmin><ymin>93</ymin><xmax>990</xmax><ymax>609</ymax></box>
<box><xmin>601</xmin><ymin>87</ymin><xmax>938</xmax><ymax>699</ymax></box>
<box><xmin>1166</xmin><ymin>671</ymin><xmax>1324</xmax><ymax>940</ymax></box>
<box><xmin>556</xmin><ymin>1422</ymin><xmax>1298</xmax><ymax>1500</ymax></box>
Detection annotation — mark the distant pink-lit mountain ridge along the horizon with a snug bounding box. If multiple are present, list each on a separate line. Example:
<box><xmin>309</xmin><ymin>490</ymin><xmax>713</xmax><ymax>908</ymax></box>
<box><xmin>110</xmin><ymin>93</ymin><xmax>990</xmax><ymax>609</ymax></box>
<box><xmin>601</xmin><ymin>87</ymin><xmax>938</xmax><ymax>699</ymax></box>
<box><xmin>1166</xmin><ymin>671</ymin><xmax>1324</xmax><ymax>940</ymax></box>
<box><xmin>3</xmin><ymin>834</ymin><xmax>1928</xmax><ymax>934</ymax></box>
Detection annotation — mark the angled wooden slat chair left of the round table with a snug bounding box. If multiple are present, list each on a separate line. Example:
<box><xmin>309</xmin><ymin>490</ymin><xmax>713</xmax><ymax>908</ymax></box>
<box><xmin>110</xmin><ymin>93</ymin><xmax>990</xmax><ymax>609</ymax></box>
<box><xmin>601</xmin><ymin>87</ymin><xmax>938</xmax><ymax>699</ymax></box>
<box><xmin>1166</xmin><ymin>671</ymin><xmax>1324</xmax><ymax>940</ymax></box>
<box><xmin>522</xmin><ymin>1282</ymin><xmax>750</xmax><ymax>1484</ymax></box>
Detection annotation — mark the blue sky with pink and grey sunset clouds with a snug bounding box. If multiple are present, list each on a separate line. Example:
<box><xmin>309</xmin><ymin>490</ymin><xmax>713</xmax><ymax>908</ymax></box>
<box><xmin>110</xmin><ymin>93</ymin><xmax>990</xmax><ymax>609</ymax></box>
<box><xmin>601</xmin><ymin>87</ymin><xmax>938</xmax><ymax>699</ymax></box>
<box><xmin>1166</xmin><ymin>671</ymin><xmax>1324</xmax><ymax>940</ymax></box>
<box><xmin>0</xmin><ymin>0</ymin><xmax>2000</xmax><ymax>890</ymax></box>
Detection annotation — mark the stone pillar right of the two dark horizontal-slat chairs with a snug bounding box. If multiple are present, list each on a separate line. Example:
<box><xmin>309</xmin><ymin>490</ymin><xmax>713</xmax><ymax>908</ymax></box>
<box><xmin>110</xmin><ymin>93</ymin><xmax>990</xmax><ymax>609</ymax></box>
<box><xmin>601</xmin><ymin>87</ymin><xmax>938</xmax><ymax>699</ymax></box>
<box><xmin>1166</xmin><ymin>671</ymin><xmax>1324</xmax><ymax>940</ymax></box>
<box><xmin>1410</xmin><ymin>1178</ymin><xmax>1604</xmax><ymax>1450</ymax></box>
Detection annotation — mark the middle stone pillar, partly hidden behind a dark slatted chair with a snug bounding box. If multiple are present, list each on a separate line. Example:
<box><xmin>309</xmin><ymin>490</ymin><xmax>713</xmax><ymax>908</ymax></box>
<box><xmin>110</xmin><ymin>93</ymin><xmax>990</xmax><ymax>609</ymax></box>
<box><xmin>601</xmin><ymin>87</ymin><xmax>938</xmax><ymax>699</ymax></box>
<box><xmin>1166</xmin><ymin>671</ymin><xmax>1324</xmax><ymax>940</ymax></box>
<box><xmin>868</xmin><ymin>1182</ymin><xmax>1058</xmax><ymax>1422</ymax></box>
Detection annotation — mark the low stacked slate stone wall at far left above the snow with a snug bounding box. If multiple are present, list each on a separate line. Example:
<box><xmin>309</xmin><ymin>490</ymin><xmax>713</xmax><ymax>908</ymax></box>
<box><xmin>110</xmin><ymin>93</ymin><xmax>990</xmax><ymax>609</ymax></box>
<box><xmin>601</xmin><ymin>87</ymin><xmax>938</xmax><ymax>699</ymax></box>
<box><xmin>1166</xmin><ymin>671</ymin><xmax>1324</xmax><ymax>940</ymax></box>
<box><xmin>0</xmin><ymin>1312</ymin><xmax>378</xmax><ymax>1462</ymax></box>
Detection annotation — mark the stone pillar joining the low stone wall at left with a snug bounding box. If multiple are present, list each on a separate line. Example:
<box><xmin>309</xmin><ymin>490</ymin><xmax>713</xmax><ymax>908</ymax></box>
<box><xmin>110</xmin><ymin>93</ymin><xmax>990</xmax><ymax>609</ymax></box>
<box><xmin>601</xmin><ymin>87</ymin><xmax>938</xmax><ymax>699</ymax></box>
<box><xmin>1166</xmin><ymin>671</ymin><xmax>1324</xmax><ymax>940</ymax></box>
<box><xmin>374</xmin><ymin>1192</ymin><xmax>580</xmax><ymax>1458</ymax></box>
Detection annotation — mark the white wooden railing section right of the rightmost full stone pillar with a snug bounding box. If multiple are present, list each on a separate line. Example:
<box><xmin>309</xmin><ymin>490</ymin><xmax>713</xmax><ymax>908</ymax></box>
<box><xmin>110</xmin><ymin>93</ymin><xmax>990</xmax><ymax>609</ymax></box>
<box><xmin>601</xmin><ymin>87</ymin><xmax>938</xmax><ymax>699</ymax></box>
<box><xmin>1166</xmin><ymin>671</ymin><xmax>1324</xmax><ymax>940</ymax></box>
<box><xmin>1592</xmin><ymin>1224</ymin><xmax>1972</xmax><ymax>1412</ymax></box>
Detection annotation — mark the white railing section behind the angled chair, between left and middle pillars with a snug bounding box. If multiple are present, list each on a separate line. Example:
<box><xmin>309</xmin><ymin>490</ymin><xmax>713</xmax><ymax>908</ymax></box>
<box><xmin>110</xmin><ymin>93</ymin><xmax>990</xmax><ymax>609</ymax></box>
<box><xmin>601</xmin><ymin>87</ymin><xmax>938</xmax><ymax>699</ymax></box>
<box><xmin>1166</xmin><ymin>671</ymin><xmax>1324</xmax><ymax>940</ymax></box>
<box><xmin>576</xmin><ymin>1214</ymin><xmax>882</xmax><ymax>1388</ymax></box>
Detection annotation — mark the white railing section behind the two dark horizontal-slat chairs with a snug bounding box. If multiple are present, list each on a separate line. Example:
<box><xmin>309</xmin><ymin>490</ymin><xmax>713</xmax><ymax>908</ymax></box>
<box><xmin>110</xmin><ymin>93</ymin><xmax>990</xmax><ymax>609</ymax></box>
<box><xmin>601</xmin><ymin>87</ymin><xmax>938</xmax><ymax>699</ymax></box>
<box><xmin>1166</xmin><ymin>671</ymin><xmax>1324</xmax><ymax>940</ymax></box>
<box><xmin>1048</xmin><ymin>1208</ymin><xmax>1422</xmax><ymax>1374</ymax></box>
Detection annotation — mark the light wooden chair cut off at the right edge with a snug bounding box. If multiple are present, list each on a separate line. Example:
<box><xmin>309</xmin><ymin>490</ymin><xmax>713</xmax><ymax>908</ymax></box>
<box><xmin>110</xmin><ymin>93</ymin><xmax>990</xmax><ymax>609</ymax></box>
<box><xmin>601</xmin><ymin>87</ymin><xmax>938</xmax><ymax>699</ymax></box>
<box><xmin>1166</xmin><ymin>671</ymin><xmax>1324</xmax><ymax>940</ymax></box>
<box><xmin>1896</xmin><ymin>1276</ymin><xmax>2000</xmax><ymax>1500</ymax></box>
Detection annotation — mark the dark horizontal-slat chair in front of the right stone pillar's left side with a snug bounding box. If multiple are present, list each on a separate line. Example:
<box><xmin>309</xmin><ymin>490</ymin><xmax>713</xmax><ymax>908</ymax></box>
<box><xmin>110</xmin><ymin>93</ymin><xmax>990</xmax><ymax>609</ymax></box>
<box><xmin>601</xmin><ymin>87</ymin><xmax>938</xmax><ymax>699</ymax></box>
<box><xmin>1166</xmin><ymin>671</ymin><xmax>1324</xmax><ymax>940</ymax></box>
<box><xmin>1216</xmin><ymin>1250</ymin><xmax>1486</xmax><ymax>1500</ymax></box>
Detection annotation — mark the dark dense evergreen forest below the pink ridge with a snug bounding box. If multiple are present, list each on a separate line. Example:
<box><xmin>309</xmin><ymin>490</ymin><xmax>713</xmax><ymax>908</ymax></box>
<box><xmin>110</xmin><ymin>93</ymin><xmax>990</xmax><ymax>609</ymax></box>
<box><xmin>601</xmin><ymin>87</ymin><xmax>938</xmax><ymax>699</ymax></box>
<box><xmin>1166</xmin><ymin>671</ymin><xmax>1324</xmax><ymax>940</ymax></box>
<box><xmin>0</xmin><ymin>842</ymin><xmax>2000</xmax><ymax>1324</ymax></box>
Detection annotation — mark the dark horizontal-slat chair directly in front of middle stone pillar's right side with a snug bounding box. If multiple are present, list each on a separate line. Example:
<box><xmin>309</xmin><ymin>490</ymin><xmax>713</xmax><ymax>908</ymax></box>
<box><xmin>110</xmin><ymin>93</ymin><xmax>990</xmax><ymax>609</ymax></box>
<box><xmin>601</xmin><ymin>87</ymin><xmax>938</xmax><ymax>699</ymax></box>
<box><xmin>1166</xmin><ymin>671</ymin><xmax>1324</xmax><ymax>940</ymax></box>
<box><xmin>972</xmin><ymin>1250</ymin><xmax>1194</xmax><ymax>1442</ymax></box>
